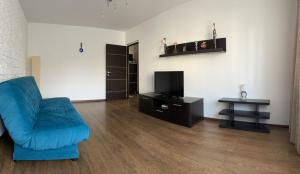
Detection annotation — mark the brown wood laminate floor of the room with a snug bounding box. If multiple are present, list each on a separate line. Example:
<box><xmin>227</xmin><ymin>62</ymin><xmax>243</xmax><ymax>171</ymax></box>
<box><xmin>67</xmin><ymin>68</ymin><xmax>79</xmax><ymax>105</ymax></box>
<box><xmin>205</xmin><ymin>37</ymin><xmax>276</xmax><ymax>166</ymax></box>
<box><xmin>0</xmin><ymin>100</ymin><xmax>300</xmax><ymax>174</ymax></box>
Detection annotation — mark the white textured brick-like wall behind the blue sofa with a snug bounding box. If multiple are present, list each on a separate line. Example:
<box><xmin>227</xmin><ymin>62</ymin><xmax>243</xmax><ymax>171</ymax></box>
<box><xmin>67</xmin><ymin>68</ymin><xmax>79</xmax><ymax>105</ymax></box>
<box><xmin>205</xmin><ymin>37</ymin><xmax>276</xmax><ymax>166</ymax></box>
<box><xmin>0</xmin><ymin>0</ymin><xmax>27</xmax><ymax>135</ymax></box>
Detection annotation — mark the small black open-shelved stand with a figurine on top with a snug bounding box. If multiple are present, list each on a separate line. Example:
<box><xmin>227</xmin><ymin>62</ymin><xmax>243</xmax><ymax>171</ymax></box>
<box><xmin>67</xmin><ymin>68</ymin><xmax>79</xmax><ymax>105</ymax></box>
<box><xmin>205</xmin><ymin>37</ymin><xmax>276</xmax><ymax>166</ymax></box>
<box><xmin>219</xmin><ymin>98</ymin><xmax>270</xmax><ymax>133</ymax></box>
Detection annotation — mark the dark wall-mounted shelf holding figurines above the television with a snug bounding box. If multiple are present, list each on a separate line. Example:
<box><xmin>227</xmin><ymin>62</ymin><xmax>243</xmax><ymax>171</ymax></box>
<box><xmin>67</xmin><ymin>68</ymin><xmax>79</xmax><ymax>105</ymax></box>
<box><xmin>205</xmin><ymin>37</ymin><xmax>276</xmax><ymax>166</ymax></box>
<box><xmin>159</xmin><ymin>38</ymin><xmax>226</xmax><ymax>58</ymax></box>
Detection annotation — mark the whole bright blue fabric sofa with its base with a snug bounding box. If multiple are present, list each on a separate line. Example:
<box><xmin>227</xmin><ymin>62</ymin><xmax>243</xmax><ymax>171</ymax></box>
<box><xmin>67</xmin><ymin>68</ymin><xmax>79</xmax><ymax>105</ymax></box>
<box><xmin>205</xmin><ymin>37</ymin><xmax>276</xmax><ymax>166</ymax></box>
<box><xmin>0</xmin><ymin>77</ymin><xmax>90</xmax><ymax>160</ymax></box>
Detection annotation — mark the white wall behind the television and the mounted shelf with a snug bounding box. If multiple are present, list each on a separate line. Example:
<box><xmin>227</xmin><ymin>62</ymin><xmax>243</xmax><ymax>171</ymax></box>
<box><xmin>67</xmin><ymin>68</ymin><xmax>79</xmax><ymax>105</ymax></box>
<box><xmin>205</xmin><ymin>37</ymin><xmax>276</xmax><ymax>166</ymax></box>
<box><xmin>126</xmin><ymin>0</ymin><xmax>297</xmax><ymax>125</ymax></box>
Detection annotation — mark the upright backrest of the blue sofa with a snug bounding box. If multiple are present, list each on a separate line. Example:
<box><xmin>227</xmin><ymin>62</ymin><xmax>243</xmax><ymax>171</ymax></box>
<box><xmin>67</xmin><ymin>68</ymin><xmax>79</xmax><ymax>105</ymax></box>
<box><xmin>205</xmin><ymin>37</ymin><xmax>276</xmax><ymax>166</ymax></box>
<box><xmin>0</xmin><ymin>77</ymin><xmax>42</xmax><ymax>145</ymax></box>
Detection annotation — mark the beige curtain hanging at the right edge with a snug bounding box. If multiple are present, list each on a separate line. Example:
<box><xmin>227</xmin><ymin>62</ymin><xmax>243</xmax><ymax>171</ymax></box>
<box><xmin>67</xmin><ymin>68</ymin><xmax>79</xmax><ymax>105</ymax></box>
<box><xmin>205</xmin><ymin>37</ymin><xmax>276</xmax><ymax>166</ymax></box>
<box><xmin>290</xmin><ymin>1</ymin><xmax>300</xmax><ymax>154</ymax></box>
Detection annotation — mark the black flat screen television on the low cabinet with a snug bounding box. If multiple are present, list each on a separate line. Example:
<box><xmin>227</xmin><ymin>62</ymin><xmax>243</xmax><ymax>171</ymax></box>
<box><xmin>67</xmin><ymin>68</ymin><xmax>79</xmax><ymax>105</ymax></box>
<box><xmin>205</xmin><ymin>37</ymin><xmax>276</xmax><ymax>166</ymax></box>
<box><xmin>154</xmin><ymin>71</ymin><xmax>184</xmax><ymax>97</ymax></box>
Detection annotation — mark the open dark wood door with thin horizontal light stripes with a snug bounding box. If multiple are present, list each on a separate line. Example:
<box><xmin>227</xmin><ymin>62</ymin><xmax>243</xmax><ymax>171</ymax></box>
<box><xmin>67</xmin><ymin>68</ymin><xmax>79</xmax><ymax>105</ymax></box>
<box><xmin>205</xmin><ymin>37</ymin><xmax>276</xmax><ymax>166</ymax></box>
<box><xmin>106</xmin><ymin>44</ymin><xmax>127</xmax><ymax>100</ymax></box>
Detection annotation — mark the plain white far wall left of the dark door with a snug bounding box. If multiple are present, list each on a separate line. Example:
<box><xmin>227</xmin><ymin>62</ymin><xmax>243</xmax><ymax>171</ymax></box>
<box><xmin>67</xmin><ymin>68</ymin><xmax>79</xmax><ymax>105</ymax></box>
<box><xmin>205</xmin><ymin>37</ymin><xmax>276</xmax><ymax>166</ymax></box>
<box><xmin>28</xmin><ymin>23</ymin><xmax>125</xmax><ymax>100</ymax></box>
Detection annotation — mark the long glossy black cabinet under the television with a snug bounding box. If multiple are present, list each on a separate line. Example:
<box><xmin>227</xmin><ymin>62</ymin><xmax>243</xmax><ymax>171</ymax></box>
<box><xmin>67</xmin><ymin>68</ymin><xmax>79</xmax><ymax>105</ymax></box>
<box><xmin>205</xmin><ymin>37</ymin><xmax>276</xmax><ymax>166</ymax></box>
<box><xmin>139</xmin><ymin>93</ymin><xmax>203</xmax><ymax>127</ymax></box>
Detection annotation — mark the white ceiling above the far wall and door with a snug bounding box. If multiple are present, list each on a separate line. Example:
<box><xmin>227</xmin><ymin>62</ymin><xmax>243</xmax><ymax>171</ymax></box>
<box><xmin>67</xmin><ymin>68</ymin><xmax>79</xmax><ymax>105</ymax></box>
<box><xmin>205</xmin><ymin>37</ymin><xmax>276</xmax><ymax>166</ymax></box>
<box><xmin>20</xmin><ymin>0</ymin><xmax>190</xmax><ymax>31</ymax></box>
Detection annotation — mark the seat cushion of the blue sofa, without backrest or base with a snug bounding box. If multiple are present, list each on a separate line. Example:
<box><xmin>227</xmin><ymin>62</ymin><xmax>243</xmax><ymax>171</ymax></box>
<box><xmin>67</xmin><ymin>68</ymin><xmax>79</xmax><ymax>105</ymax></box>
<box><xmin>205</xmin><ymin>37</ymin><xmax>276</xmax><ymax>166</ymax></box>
<box><xmin>22</xmin><ymin>98</ymin><xmax>89</xmax><ymax>150</ymax></box>
